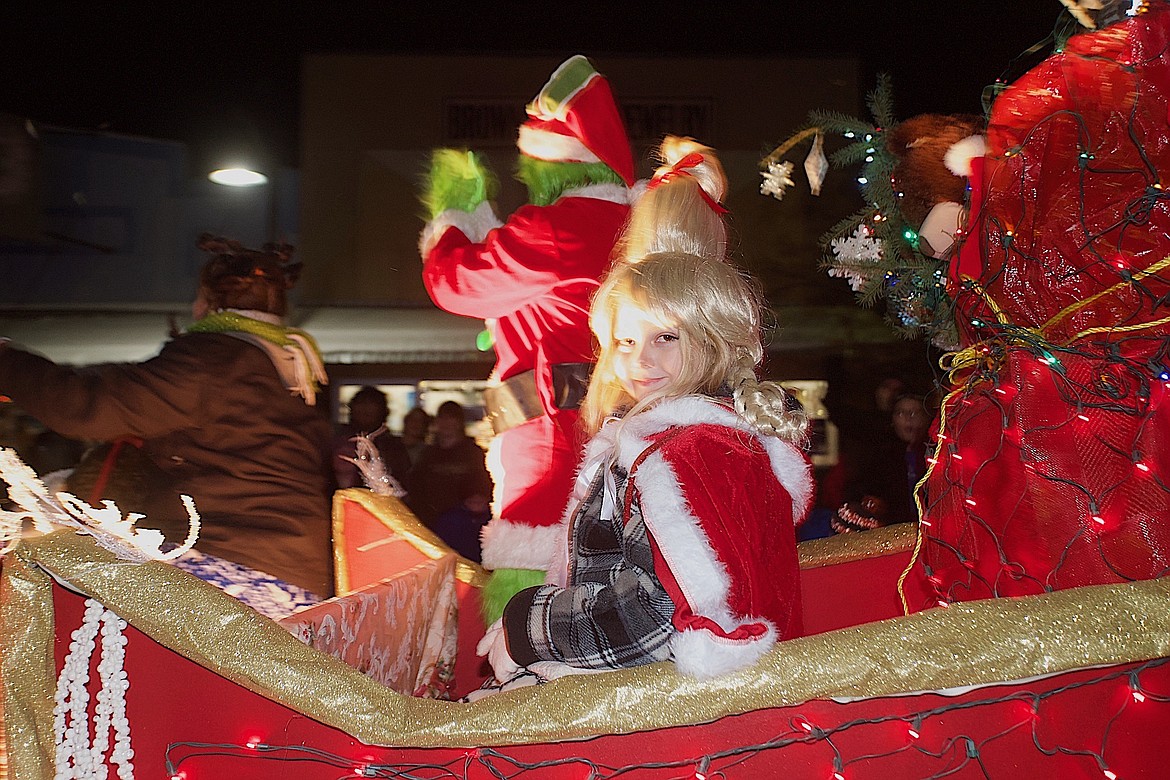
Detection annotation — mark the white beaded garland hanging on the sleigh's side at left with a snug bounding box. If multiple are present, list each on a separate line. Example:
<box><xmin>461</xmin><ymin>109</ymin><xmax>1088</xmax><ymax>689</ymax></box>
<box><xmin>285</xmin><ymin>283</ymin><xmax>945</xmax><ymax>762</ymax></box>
<box><xmin>53</xmin><ymin>599</ymin><xmax>135</xmax><ymax>780</ymax></box>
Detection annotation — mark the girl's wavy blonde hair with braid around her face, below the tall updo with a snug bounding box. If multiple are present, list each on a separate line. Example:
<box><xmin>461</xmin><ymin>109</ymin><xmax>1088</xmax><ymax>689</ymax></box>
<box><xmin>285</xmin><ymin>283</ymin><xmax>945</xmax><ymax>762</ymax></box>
<box><xmin>581</xmin><ymin>253</ymin><xmax>807</xmax><ymax>441</ymax></box>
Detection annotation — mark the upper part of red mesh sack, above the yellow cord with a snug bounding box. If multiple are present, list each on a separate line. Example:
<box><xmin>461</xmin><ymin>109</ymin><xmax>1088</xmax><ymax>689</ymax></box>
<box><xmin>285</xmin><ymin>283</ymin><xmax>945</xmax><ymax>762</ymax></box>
<box><xmin>959</xmin><ymin>11</ymin><xmax>1170</xmax><ymax>344</ymax></box>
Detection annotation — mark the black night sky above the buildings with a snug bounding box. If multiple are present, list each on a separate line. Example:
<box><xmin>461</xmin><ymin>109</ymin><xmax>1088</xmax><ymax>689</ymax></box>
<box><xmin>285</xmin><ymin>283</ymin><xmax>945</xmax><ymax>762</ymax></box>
<box><xmin>0</xmin><ymin>0</ymin><xmax>1068</xmax><ymax>165</ymax></box>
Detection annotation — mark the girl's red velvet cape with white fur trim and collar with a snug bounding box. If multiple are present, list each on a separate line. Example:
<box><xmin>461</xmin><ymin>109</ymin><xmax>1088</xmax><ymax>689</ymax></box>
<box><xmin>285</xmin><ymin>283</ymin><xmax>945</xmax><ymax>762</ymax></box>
<box><xmin>549</xmin><ymin>396</ymin><xmax>813</xmax><ymax>677</ymax></box>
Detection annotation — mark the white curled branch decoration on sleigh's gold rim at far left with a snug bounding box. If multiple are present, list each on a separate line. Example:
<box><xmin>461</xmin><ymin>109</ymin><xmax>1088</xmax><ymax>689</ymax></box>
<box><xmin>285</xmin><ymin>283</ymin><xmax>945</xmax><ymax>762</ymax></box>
<box><xmin>0</xmin><ymin>448</ymin><xmax>200</xmax><ymax>564</ymax></box>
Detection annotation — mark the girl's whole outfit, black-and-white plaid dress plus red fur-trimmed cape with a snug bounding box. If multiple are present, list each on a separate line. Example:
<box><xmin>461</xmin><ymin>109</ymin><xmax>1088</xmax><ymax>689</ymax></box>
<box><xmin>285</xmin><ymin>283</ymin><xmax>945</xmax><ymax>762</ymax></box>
<box><xmin>503</xmin><ymin>396</ymin><xmax>812</xmax><ymax>677</ymax></box>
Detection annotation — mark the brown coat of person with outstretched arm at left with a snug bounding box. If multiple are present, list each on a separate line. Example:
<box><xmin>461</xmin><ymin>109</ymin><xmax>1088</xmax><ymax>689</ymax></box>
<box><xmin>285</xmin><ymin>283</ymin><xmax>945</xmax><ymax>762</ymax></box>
<box><xmin>0</xmin><ymin>333</ymin><xmax>333</xmax><ymax>596</ymax></box>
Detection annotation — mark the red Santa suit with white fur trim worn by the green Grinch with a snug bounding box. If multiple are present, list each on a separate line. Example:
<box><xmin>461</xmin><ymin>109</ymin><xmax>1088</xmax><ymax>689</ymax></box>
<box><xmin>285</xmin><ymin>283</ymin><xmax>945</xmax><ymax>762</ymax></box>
<box><xmin>420</xmin><ymin>184</ymin><xmax>629</xmax><ymax>570</ymax></box>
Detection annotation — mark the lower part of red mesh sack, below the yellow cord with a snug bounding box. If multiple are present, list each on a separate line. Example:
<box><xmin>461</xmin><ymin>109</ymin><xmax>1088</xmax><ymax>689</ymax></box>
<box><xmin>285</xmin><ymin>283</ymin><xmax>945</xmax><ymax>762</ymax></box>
<box><xmin>922</xmin><ymin>350</ymin><xmax>1170</xmax><ymax>601</ymax></box>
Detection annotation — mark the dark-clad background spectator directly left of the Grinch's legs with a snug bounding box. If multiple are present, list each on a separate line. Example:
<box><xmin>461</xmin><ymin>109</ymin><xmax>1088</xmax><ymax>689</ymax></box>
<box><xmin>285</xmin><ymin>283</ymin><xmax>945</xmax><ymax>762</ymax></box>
<box><xmin>405</xmin><ymin>401</ymin><xmax>493</xmax><ymax>561</ymax></box>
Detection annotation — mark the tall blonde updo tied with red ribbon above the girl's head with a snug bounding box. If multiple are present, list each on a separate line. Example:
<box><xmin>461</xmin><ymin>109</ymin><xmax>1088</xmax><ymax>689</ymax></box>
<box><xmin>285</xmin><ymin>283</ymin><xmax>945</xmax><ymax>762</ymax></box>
<box><xmin>614</xmin><ymin>136</ymin><xmax>728</xmax><ymax>263</ymax></box>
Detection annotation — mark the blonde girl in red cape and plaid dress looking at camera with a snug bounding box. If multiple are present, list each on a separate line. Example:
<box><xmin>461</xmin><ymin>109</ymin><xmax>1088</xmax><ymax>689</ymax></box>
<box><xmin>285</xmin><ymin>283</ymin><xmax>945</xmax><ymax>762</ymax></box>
<box><xmin>480</xmin><ymin>138</ymin><xmax>812</xmax><ymax>681</ymax></box>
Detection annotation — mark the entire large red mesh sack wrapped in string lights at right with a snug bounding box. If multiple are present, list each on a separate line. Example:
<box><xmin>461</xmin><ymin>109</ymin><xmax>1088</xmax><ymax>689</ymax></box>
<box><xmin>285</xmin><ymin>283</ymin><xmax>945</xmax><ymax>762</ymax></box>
<box><xmin>920</xmin><ymin>8</ymin><xmax>1170</xmax><ymax>601</ymax></box>
